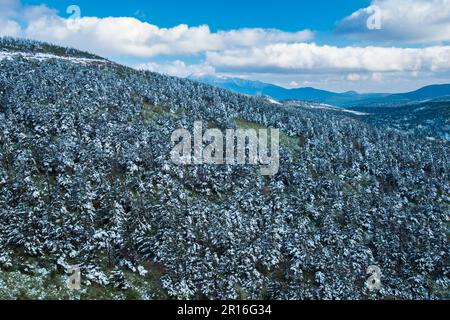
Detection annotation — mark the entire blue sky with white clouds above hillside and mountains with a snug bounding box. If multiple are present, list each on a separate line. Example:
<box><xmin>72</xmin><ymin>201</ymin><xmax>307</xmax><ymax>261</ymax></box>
<box><xmin>0</xmin><ymin>0</ymin><xmax>450</xmax><ymax>92</ymax></box>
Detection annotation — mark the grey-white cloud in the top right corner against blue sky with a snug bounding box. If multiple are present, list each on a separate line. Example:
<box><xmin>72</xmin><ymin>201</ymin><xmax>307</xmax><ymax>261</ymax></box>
<box><xmin>336</xmin><ymin>0</ymin><xmax>450</xmax><ymax>45</ymax></box>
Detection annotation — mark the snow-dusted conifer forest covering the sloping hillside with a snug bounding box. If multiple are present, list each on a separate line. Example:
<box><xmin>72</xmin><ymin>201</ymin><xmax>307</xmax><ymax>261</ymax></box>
<box><xmin>0</xmin><ymin>39</ymin><xmax>450</xmax><ymax>299</ymax></box>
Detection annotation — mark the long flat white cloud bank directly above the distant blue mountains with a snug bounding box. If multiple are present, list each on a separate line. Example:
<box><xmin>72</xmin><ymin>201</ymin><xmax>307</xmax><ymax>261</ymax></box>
<box><xmin>207</xmin><ymin>43</ymin><xmax>450</xmax><ymax>73</ymax></box>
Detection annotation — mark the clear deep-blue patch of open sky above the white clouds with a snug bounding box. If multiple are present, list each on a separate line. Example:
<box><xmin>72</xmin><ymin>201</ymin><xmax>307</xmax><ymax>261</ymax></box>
<box><xmin>23</xmin><ymin>0</ymin><xmax>370</xmax><ymax>31</ymax></box>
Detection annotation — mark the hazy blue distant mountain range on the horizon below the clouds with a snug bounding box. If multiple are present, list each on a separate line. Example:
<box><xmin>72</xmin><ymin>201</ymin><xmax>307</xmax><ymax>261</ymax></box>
<box><xmin>191</xmin><ymin>76</ymin><xmax>450</xmax><ymax>107</ymax></box>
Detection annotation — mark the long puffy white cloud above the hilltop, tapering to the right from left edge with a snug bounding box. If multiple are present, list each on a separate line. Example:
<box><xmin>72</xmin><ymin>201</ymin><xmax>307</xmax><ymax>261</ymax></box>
<box><xmin>0</xmin><ymin>0</ymin><xmax>313</xmax><ymax>57</ymax></box>
